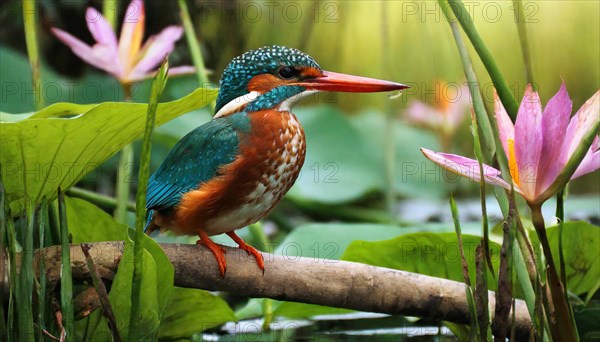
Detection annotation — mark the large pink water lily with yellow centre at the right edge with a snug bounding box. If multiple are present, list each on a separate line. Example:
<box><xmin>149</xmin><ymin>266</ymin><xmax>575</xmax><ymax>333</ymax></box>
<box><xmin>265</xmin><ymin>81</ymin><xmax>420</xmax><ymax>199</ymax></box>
<box><xmin>421</xmin><ymin>83</ymin><xmax>600</xmax><ymax>204</ymax></box>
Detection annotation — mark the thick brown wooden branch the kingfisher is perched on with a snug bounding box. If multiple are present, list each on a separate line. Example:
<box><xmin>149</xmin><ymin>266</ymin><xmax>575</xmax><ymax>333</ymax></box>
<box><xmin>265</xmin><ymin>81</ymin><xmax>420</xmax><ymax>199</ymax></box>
<box><xmin>9</xmin><ymin>241</ymin><xmax>532</xmax><ymax>339</ymax></box>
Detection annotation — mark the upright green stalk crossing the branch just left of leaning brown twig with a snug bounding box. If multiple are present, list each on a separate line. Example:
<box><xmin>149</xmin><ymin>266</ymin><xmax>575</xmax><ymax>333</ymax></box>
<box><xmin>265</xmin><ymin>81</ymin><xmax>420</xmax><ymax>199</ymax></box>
<box><xmin>58</xmin><ymin>189</ymin><xmax>75</xmax><ymax>336</ymax></box>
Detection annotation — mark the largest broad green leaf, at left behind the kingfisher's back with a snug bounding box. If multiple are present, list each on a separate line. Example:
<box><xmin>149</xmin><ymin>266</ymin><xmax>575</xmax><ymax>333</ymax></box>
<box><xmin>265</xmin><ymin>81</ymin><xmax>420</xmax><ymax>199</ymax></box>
<box><xmin>0</xmin><ymin>88</ymin><xmax>216</xmax><ymax>213</ymax></box>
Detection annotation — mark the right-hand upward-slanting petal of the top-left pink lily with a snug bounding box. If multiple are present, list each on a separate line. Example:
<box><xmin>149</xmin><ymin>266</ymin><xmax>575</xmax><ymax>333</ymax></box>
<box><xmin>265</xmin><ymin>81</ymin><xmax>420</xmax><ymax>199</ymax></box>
<box><xmin>131</xmin><ymin>26</ymin><xmax>183</xmax><ymax>78</ymax></box>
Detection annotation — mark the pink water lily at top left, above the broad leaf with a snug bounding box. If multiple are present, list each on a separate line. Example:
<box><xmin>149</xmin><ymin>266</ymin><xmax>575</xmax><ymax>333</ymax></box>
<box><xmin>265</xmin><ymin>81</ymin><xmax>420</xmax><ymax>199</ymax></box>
<box><xmin>52</xmin><ymin>0</ymin><xmax>195</xmax><ymax>84</ymax></box>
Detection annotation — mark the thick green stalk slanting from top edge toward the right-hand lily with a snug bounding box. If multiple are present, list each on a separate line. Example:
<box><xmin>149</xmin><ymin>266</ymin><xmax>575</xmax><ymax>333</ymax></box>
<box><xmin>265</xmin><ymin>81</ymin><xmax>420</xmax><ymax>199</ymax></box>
<box><xmin>442</xmin><ymin>0</ymin><xmax>519</xmax><ymax>121</ymax></box>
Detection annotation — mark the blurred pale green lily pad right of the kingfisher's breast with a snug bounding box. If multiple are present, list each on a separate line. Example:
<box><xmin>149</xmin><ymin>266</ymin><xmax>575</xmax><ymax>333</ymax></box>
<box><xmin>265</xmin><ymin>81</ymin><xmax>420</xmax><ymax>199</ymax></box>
<box><xmin>288</xmin><ymin>106</ymin><xmax>446</xmax><ymax>204</ymax></box>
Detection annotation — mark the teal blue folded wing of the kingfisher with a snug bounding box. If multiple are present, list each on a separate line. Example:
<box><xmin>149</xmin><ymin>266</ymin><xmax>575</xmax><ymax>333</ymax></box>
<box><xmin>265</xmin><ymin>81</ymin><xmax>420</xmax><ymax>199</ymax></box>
<box><xmin>146</xmin><ymin>113</ymin><xmax>249</xmax><ymax>210</ymax></box>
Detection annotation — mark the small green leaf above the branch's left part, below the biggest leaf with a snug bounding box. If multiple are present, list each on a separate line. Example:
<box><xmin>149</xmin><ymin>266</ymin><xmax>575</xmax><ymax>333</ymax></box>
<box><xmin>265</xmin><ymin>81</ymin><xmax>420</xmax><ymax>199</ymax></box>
<box><xmin>65</xmin><ymin>196</ymin><xmax>130</xmax><ymax>243</ymax></box>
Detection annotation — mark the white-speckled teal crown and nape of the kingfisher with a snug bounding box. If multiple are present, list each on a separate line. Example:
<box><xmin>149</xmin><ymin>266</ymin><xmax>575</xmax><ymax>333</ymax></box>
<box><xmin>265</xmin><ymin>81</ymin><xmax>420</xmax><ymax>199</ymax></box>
<box><xmin>215</xmin><ymin>45</ymin><xmax>321</xmax><ymax>113</ymax></box>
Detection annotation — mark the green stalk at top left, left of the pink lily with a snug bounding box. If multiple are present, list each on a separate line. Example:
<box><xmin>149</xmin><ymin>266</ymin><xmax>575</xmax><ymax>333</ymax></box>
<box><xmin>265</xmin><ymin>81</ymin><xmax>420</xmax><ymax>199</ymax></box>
<box><xmin>23</xmin><ymin>0</ymin><xmax>44</xmax><ymax>110</ymax></box>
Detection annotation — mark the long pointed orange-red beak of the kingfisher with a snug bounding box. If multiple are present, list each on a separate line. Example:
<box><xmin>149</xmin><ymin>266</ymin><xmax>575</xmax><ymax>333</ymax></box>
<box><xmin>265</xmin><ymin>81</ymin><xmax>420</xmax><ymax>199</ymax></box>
<box><xmin>297</xmin><ymin>71</ymin><xmax>410</xmax><ymax>93</ymax></box>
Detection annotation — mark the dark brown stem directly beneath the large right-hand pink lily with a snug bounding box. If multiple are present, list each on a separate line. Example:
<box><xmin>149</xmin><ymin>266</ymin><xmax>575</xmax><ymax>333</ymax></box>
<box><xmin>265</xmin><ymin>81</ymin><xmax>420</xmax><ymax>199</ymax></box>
<box><xmin>530</xmin><ymin>204</ymin><xmax>579</xmax><ymax>341</ymax></box>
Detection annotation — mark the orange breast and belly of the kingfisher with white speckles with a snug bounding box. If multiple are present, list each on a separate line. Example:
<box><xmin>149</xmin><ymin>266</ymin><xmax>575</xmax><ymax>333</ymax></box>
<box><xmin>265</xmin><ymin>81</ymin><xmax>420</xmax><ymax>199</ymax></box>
<box><xmin>170</xmin><ymin>110</ymin><xmax>306</xmax><ymax>235</ymax></box>
